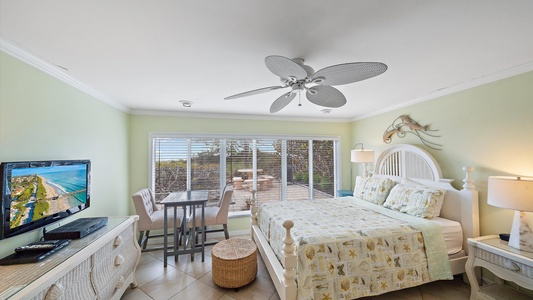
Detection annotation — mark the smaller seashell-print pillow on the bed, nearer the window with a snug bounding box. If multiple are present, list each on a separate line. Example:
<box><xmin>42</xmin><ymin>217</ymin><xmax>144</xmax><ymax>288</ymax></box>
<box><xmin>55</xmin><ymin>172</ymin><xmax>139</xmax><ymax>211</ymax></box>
<box><xmin>353</xmin><ymin>176</ymin><xmax>393</xmax><ymax>205</ymax></box>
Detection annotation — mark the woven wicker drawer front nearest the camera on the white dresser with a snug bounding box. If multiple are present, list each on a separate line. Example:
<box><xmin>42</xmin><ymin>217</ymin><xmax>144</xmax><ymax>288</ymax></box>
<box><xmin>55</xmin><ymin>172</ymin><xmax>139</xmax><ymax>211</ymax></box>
<box><xmin>32</xmin><ymin>259</ymin><xmax>96</xmax><ymax>300</ymax></box>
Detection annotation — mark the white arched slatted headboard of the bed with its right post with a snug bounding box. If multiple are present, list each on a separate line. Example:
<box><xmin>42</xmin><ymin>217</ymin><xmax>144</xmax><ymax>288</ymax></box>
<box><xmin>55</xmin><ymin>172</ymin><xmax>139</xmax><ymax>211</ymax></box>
<box><xmin>373</xmin><ymin>144</ymin><xmax>479</xmax><ymax>262</ymax></box>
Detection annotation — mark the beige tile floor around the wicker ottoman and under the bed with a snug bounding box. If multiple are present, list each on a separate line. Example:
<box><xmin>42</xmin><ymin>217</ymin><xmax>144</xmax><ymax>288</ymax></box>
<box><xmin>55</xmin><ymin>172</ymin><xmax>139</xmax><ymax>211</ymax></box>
<box><xmin>122</xmin><ymin>237</ymin><xmax>470</xmax><ymax>300</ymax></box>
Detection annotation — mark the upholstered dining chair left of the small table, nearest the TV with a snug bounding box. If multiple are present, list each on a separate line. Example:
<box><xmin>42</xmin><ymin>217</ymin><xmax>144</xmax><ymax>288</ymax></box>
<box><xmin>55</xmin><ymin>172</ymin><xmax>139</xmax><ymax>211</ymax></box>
<box><xmin>131</xmin><ymin>189</ymin><xmax>183</xmax><ymax>252</ymax></box>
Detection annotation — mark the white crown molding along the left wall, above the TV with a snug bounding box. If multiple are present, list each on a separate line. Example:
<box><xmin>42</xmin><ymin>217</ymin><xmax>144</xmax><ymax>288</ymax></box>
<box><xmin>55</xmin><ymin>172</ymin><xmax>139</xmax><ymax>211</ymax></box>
<box><xmin>0</xmin><ymin>35</ymin><xmax>129</xmax><ymax>112</ymax></box>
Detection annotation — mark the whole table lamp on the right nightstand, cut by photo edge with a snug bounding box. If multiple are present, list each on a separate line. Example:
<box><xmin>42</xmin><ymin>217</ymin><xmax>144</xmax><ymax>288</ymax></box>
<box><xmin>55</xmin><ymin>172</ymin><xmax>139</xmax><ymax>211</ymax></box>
<box><xmin>487</xmin><ymin>176</ymin><xmax>533</xmax><ymax>252</ymax></box>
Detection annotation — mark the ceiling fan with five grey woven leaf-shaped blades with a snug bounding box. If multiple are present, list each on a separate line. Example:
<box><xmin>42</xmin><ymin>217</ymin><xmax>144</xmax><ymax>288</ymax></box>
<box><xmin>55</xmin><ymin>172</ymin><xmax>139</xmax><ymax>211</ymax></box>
<box><xmin>224</xmin><ymin>55</ymin><xmax>387</xmax><ymax>113</ymax></box>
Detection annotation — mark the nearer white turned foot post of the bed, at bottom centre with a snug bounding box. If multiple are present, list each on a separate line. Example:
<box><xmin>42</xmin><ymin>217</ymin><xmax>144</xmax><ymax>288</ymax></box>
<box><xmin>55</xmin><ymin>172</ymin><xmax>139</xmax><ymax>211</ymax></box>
<box><xmin>281</xmin><ymin>220</ymin><xmax>297</xmax><ymax>299</ymax></box>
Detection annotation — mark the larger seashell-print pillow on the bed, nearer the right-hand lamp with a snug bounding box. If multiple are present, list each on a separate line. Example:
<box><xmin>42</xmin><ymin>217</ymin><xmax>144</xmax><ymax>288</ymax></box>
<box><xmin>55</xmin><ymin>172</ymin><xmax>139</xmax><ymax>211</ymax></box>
<box><xmin>383</xmin><ymin>184</ymin><xmax>446</xmax><ymax>219</ymax></box>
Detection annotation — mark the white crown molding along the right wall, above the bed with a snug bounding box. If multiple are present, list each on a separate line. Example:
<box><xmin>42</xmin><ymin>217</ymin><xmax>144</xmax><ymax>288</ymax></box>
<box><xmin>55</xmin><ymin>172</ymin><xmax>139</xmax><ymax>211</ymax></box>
<box><xmin>350</xmin><ymin>61</ymin><xmax>533</xmax><ymax>121</ymax></box>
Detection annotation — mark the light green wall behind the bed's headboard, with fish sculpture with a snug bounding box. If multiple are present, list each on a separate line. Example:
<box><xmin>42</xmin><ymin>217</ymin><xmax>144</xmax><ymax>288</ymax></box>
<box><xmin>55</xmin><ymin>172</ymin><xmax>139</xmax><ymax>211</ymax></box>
<box><xmin>352</xmin><ymin>72</ymin><xmax>533</xmax><ymax>235</ymax></box>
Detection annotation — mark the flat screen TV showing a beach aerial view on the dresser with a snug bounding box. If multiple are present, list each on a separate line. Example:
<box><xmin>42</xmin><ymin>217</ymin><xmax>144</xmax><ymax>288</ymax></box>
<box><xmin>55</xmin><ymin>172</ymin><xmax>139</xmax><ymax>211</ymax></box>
<box><xmin>0</xmin><ymin>160</ymin><xmax>91</xmax><ymax>239</ymax></box>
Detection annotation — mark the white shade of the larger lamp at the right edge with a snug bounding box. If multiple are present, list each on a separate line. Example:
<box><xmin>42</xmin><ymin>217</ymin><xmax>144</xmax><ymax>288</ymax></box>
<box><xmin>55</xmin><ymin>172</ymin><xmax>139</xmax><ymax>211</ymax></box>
<box><xmin>487</xmin><ymin>176</ymin><xmax>533</xmax><ymax>211</ymax></box>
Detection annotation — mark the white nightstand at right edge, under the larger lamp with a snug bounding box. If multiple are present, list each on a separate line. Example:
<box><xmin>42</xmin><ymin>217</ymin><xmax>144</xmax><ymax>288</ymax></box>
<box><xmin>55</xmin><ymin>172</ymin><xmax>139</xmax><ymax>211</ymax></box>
<box><xmin>466</xmin><ymin>235</ymin><xmax>533</xmax><ymax>300</ymax></box>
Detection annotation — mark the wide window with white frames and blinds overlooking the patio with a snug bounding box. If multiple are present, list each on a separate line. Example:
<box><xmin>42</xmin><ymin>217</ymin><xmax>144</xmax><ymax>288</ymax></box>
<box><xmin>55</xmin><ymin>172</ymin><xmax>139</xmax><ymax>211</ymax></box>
<box><xmin>150</xmin><ymin>134</ymin><xmax>339</xmax><ymax>212</ymax></box>
